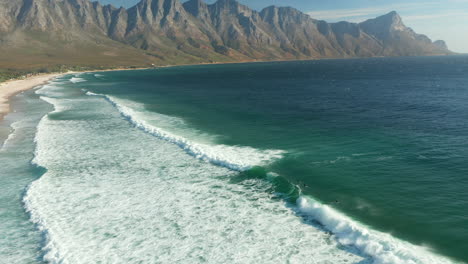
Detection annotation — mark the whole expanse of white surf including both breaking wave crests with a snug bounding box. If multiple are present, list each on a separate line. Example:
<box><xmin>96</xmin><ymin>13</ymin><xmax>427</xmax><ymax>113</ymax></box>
<box><xmin>24</xmin><ymin>78</ymin><xmax>460</xmax><ymax>264</ymax></box>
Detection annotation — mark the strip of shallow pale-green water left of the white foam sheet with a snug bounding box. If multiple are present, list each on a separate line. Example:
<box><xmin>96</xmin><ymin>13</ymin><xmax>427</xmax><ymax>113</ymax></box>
<box><xmin>0</xmin><ymin>89</ymin><xmax>49</xmax><ymax>264</ymax></box>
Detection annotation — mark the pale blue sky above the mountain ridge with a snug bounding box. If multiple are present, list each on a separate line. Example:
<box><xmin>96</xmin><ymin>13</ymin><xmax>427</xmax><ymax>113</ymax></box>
<box><xmin>99</xmin><ymin>0</ymin><xmax>468</xmax><ymax>53</ymax></box>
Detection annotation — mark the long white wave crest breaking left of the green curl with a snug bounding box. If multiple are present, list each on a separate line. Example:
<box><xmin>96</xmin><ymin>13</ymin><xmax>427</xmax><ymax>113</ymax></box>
<box><xmin>86</xmin><ymin>92</ymin><xmax>284</xmax><ymax>171</ymax></box>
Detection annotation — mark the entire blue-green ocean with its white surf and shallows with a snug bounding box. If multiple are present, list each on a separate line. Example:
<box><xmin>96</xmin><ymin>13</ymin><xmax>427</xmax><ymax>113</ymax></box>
<box><xmin>0</xmin><ymin>56</ymin><xmax>468</xmax><ymax>264</ymax></box>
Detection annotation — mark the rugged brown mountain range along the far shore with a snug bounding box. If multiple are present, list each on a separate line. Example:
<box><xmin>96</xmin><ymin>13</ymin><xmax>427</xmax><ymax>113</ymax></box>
<box><xmin>0</xmin><ymin>0</ymin><xmax>451</xmax><ymax>69</ymax></box>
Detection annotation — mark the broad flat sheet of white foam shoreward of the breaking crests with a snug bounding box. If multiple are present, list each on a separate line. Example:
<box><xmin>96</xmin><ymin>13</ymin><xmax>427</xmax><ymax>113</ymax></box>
<box><xmin>23</xmin><ymin>91</ymin><xmax>362</xmax><ymax>264</ymax></box>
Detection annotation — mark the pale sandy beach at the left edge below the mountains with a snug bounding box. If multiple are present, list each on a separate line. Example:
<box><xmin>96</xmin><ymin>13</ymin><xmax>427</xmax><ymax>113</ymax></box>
<box><xmin>0</xmin><ymin>73</ymin><xmax>64</xmax><ymax>120</ymax></box>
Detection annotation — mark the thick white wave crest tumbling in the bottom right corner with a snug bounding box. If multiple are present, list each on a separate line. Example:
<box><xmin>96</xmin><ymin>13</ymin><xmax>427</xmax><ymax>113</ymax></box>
<box><xmin>296</xmin><ymin>195</ymin><xmax>455</xmax><ymax>264</ymax></box>
